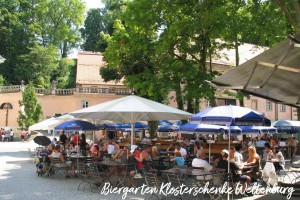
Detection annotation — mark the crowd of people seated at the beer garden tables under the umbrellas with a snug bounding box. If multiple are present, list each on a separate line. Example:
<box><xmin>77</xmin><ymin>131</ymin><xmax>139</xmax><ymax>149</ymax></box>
<box><xmin>32</xmin><ymin>132</ymin><xmax>297</xmax><ymax>192</ymax></box>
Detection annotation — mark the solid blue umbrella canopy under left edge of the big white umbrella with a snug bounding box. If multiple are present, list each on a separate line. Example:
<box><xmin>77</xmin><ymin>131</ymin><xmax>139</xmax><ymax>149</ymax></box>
<box><xmin>55</xmin><ymin>120</ymin><xmax>98</xmax><ymax>131</ymax></box>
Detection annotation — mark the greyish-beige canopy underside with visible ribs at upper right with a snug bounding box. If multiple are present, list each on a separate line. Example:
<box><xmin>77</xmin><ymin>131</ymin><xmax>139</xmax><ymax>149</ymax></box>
<box><xmin>211</xmin><ymin>33</ymin><xmax>300</xmax><ymax>107</ymax></box>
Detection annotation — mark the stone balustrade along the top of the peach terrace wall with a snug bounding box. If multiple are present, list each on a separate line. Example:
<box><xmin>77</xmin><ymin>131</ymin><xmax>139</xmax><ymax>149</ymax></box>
<box><xmin>0</xmin><ymin>85</ymin><xmax>132</xmax><ymax>95</ymax></box>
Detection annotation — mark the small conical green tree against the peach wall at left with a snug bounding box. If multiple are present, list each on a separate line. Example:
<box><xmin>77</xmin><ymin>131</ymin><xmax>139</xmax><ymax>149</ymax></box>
<box><xmin>17</xmin><ymin>82</ymin><xmax>42</xmax><ymax>130</ymax></box>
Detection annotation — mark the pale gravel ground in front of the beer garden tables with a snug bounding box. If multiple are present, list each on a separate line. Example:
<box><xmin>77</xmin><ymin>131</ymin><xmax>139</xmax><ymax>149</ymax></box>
<box><xmin>0</xmin><ymin>141</ymin><xmax>296</xmax><ymax>200</ymax></box>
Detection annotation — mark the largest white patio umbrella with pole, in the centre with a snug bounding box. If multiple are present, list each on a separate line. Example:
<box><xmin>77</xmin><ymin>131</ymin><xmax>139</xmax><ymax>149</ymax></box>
<box><xmin>69</xmin><ymin>95</ymin><xmax>192</xmax><ymax>145</ymax></box>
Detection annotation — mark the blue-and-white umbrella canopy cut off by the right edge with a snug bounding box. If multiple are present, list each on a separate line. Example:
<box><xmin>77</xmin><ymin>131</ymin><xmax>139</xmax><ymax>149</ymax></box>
<box><xmin>272</xmin><ymin>120</ymin><xmax>300</xmax><ymax>134</ymax></box>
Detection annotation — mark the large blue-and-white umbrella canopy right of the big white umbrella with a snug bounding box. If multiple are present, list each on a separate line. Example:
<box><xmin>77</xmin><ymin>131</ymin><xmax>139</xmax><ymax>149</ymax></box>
<box><xmin>191</xmin><ymin>105</ymin><xmax>271</xmax><ymax>125</ymax></box>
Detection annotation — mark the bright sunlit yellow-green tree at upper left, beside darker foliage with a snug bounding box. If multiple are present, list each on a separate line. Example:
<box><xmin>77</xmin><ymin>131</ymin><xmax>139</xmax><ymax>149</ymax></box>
<box><xmin>31</xmin><ymin>0</ymin><xmax>85</xmax><ymax>58</ymax></box>
